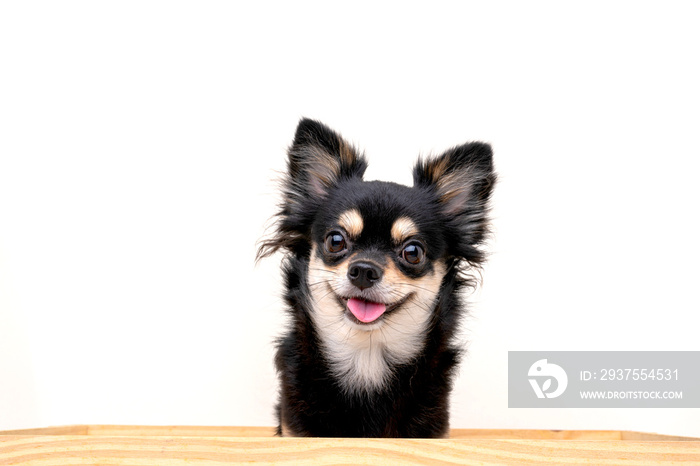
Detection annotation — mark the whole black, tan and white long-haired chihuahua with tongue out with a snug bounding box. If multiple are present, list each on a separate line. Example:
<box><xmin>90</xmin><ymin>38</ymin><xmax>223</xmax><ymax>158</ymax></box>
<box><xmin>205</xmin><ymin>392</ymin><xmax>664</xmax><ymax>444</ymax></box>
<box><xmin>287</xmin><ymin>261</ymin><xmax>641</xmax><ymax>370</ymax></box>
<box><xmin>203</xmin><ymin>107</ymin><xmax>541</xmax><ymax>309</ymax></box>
<box><xmin>258</xmin><ymin>119</ymin><xmax>496</xmax><ymax>437</ymax></box>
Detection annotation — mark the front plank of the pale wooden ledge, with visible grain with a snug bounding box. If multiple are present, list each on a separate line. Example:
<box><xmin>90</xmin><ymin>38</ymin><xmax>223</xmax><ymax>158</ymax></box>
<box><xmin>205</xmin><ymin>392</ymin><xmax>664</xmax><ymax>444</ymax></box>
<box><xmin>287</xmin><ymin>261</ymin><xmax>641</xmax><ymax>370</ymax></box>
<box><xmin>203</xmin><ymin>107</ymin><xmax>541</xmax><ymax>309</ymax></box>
<box><xmin>0</xmin><ymin>435</ymin><xmax>700</xmax><ymax>466</ymax></box>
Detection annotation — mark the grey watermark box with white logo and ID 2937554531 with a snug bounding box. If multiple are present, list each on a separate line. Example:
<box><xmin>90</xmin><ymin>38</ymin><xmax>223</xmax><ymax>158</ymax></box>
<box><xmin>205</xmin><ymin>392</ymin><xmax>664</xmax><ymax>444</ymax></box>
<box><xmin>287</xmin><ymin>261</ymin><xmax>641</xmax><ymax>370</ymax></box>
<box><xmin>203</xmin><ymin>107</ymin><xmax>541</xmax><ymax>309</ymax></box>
<box><xmin>508</xmin><ymin>351</ymin><xmax>700</xmax><ymax>409</ymax></box>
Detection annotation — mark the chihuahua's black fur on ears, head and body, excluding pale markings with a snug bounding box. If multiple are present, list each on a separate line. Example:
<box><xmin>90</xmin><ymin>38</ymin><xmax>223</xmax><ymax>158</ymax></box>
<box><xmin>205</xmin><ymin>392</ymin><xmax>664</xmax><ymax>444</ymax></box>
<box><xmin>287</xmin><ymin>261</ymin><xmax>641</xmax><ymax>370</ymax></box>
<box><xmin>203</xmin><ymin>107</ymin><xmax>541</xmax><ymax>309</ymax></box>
<box><xmin>258</xmin><ymin>119</ymin><xmax>496</xmax><ymax>437</ymax></box>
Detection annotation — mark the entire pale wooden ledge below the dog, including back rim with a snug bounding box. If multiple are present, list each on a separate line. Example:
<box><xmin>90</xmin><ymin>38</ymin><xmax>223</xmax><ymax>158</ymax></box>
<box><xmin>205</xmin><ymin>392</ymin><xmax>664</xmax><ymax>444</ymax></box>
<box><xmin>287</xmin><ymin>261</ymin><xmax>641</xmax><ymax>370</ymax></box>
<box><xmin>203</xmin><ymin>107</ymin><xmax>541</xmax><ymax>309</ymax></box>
<box><xmin>0</xmin><ymin>426</ymin><xmax>700</xmax><ymax>466</ymax></box>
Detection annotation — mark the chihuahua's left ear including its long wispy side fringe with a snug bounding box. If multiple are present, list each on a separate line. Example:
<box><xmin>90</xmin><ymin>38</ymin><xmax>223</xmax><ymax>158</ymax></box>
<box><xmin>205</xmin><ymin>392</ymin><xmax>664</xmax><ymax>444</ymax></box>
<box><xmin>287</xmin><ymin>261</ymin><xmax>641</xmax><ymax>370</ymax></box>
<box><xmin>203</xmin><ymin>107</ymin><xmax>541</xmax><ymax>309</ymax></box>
<box><xmin>257</xmin><ymin>118</ymin><xmax>367</xmax><ymax>260</ymax></box>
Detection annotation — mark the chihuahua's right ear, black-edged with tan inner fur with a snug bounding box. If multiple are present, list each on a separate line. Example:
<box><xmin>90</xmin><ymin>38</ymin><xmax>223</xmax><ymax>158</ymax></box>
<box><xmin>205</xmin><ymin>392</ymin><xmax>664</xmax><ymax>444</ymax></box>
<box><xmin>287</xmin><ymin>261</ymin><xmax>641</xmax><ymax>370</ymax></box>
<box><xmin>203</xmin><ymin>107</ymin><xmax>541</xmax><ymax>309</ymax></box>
<box><xmin>413</xmin><ymin>142</ymin><xmax>496</xmax><ymax>264</ymax></box>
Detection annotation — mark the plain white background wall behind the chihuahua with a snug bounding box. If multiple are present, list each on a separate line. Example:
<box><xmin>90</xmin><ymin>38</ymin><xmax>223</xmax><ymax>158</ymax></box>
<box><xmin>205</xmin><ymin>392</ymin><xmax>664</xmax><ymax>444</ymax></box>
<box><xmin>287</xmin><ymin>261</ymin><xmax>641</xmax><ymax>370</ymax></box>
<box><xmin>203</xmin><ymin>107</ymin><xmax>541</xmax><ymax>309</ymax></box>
<box><xmin>0</xmin><ymin>1</ymin><xmax>700</xmax><ymax>436</ymax></box>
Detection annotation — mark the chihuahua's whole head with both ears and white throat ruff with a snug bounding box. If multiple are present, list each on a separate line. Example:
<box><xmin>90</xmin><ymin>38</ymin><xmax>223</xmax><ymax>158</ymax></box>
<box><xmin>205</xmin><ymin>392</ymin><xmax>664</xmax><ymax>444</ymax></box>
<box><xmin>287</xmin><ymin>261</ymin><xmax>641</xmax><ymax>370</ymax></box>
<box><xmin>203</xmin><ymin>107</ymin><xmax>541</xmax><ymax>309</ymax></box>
<box><xmin>260</xmin><ymin>120</ymin><xmax>495</xmax><ymax>392</ymax></box>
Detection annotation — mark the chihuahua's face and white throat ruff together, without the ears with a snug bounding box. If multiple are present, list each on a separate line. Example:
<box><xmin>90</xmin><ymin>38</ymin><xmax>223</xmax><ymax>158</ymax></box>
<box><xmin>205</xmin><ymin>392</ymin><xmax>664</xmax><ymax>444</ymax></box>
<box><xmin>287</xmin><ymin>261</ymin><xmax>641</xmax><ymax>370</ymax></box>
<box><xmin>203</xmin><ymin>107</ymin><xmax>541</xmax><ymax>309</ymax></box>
<box><xmin>308</xmin><ymin>181</ymin><xmax>445</xmax><ymax>391</ymax></box>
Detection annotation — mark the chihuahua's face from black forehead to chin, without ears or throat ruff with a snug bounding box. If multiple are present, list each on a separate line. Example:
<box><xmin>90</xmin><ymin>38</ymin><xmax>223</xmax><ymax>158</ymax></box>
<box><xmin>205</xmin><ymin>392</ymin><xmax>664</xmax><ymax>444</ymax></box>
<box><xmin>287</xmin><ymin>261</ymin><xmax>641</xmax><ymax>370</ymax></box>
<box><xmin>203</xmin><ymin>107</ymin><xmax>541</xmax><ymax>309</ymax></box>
<box><xmin>309</xmin><ymin>182</ymin><xmax>445</xmax><ymax>331</ymax></box>
